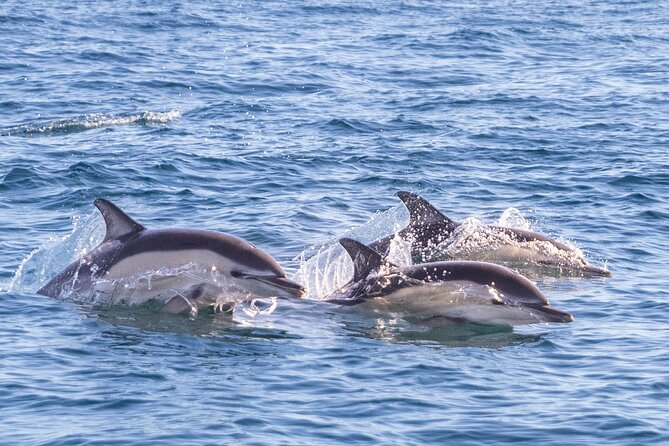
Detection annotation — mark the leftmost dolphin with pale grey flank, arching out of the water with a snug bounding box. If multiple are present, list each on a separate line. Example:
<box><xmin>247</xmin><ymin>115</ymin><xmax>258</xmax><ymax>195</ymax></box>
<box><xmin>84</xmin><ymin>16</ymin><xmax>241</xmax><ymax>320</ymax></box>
<box><xmin>37</xmin><ymin>199</ymin><xmax>304</xmax><ymax>313</ymax></box>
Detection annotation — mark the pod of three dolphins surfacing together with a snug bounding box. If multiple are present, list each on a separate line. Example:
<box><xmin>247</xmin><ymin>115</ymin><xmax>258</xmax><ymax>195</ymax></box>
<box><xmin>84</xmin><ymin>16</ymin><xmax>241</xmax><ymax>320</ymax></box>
<box><xmin>37</xmin><ymin>191</ymin><xmax>610</xmax><ymax>326</ymax></box>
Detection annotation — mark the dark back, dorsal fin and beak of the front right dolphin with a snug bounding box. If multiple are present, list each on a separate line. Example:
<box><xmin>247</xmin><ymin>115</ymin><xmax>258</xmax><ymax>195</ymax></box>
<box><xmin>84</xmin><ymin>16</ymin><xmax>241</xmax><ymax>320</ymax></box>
<box><xmin>326</xmin><ymin>238</ymin><xmax>574</xmax><ymax>323</ymax></box>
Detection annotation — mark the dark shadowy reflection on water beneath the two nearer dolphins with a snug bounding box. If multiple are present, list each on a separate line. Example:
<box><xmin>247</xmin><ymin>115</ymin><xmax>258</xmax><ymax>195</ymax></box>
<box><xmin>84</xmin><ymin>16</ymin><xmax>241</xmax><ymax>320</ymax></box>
<box><xmin>79</xmin><ymin>296</ymin><xmax>541</xmax><ymax>349</ymax></box>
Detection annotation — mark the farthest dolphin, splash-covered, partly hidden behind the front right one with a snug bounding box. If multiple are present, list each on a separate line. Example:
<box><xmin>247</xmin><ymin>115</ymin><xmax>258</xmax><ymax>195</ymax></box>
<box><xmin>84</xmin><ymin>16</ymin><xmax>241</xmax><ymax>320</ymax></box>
<box><xmin>370</xmin><ymin>191</ymin><xmax>611</xmax><ymax>276</ymax></box>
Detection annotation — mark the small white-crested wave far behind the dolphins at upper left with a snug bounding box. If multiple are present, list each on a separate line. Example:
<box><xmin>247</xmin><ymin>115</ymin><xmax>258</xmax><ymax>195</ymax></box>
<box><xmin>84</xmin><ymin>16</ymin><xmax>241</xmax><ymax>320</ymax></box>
<box><xmin>0</xmin><ymin>110</ymin><xmax>181</xmax><ymax>136</ymax></box>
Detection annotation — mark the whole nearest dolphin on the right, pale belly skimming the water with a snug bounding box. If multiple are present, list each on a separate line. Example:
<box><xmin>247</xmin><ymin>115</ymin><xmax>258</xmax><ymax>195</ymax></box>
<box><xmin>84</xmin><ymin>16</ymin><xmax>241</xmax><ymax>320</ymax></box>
<box><xmin>326</xmin><ymin>238</ymin><xmax>573</xmax><ymax>326</ymax></box>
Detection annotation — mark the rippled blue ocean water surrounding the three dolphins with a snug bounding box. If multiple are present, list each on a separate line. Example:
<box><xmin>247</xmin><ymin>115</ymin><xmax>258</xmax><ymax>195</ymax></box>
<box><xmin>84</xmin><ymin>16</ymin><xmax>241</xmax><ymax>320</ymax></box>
<box><xmin>0</xmin><ymin>0</ymin><xmax>669</xmax><ymax>444</ymax></box>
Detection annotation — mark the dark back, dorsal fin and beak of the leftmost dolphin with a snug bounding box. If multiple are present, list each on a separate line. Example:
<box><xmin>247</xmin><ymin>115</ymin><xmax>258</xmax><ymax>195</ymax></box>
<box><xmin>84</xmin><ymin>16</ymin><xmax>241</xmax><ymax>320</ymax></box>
<box><xmin>37</xmin><ymin>199</ymin><xmax>304</xmax><ymax>297</ymax></box>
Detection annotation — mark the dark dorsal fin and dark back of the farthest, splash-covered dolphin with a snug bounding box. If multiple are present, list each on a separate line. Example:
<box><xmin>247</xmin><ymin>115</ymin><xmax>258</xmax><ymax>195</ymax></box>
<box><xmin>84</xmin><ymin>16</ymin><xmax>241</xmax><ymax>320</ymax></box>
<box><xmin>369</xmin><ymin>191</ymin><xmax>611</xmax><ymax>277</ymax></box>
